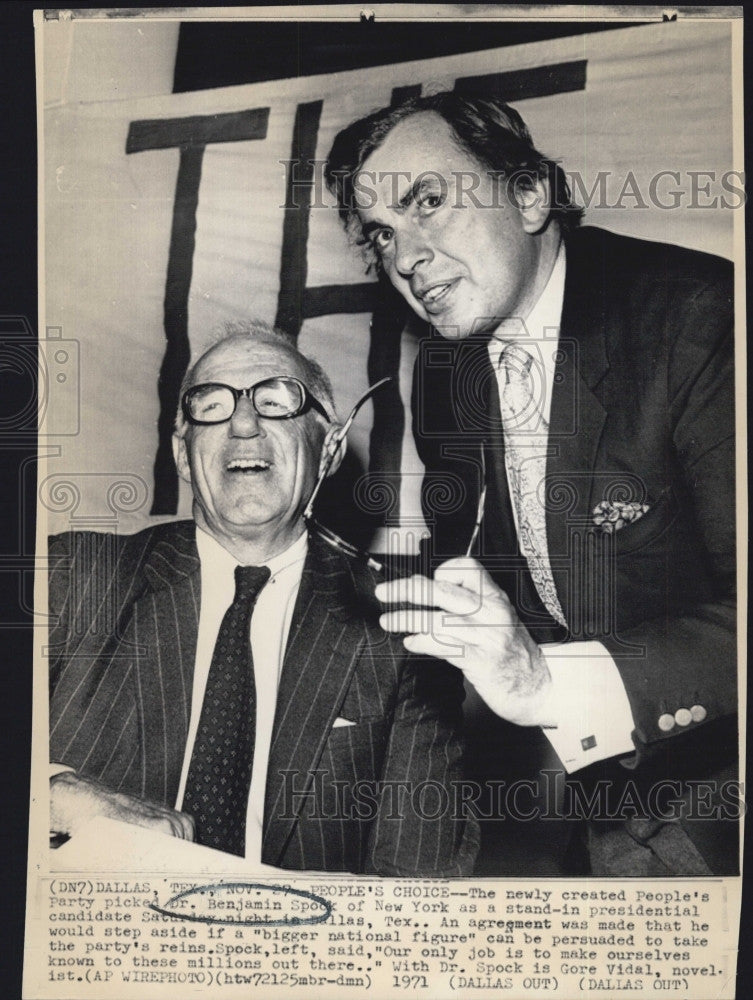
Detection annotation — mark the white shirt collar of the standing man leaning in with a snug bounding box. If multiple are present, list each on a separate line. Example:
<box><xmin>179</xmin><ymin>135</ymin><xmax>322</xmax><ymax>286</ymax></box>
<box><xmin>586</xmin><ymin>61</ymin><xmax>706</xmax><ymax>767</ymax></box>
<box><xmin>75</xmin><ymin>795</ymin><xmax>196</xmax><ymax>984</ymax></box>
<box><xmin>489</xmin><ymin>241</ymin><xmax>565</xmax><ymax>381</ymax></box>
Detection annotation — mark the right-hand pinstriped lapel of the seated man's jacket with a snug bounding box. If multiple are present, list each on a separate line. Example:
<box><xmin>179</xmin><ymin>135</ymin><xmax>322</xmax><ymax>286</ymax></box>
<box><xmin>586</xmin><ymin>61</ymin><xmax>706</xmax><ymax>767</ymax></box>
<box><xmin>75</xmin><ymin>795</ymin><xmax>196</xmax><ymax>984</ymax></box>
<box><xmin>262</xmin><ymin>537</ymin><xmax>365</xmax><ymax>864</ymax></box>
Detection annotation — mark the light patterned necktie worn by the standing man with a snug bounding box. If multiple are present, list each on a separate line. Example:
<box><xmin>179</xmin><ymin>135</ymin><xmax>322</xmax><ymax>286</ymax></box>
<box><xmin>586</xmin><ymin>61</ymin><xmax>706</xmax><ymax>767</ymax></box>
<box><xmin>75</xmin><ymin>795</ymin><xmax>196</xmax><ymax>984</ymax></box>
<box><xmin>500</xmin><ymin>344</ymin><xmax>567</xmax><ymax>626</ymax></box>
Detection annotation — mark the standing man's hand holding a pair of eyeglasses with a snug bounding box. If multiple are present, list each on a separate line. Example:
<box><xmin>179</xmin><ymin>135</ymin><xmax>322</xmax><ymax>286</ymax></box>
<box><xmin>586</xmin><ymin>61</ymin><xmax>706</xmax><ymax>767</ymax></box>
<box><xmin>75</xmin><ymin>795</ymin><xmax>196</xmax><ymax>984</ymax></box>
<box><xmin>376</xmin><ymin>557</ymin><xmax>556</xmax><ymax>726</ymax></box>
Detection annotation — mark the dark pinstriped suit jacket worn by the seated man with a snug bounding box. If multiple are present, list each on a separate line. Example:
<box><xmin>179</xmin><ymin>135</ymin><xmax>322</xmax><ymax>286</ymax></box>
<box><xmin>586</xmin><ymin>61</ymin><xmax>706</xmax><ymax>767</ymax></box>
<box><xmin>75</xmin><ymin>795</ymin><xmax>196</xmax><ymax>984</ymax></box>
<box><xmin>49</xmin><ymin>521</ymin><xmax>478</xmax><ymax>875</ymax></box>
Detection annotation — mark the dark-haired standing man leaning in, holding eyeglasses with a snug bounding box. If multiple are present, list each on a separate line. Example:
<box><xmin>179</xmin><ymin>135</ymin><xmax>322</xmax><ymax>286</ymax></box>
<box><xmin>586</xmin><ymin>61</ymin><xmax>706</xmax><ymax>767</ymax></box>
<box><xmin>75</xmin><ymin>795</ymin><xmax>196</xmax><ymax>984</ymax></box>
<box><xmin>327</xmin><ymin>93</ymin><xmax>737</xmax><ymax>874</ymax></box>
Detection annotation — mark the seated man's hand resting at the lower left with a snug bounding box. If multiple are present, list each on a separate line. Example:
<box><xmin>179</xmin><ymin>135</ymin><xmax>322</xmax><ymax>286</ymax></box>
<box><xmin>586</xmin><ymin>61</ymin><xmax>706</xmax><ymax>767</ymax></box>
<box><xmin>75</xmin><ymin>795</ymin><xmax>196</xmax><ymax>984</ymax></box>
<box><xmin>50</xmin><ymin>771</ymin><xmax>194</xmax><ymax>840</ymax></box>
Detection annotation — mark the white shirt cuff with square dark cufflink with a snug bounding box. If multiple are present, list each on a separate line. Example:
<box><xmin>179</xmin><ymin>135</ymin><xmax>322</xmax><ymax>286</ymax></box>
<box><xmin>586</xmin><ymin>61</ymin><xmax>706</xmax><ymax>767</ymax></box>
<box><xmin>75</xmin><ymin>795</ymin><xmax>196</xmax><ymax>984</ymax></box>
<box><xmin>541</xmin><ymin>640</ymin><xmax>635</xmax><ymax>774</ymax></box>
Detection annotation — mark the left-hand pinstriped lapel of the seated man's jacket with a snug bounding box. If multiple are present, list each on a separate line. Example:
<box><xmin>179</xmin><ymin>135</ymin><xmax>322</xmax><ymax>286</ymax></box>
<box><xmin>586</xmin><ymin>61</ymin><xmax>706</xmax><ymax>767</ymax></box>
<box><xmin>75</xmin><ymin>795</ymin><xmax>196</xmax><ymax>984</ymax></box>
<box><xmin>127</xmin><ymin>522</ymin><xmax>201</xmax><ymax>805</ymax></box>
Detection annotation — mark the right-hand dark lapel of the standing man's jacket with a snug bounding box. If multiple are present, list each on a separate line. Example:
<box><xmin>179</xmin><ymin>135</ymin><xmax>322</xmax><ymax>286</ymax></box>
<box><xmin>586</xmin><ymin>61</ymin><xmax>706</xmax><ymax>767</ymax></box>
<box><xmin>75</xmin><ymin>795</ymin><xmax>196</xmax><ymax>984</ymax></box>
<box><xmin>546</xmin><ymin>230</ymin><xmax>609</xmax><ymax>619</ymax></box>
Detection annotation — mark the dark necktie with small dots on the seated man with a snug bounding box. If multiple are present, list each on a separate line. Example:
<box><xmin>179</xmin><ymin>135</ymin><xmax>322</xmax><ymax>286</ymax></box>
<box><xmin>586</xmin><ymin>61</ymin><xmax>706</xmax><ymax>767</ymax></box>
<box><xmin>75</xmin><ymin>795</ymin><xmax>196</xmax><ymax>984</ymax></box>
<box><xmin>183</xmin><ymin>566</ymin><xmax>270</xmax><ymax>857</ymax></box>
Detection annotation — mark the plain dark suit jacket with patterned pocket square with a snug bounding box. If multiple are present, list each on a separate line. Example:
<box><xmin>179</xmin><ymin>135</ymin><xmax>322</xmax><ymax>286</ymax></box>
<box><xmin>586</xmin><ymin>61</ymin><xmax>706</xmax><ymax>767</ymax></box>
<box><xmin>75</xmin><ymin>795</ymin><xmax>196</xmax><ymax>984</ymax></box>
<box><xmin>413</xmin><ymin>228</ymin><xmax>737</xmax><ymax>864</ymax></box>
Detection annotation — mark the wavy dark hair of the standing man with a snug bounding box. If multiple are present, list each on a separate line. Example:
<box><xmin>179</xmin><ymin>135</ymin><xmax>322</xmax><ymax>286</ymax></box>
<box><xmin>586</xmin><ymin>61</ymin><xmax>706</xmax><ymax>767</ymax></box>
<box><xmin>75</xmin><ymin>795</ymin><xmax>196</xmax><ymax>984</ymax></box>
<box><xmin>325</xmin><ymin>91</ymin><xmax>583</xmax><ymax>240</ymax></box>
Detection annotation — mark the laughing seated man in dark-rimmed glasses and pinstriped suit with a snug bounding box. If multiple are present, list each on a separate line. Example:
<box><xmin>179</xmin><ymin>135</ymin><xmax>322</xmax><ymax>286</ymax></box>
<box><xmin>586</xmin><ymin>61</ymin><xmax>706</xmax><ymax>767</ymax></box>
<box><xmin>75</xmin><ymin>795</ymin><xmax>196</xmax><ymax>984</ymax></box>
<box><xmin>50</xmin><ymin>325</ymin><xmax>477</xmax><ymax>875</ymax></box>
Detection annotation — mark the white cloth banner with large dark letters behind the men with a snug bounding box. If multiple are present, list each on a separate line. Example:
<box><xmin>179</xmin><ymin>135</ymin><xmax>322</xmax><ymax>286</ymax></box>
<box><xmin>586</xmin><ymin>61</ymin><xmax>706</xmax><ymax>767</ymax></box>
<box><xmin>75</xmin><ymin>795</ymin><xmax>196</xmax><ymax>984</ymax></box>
<box><xmin>41</xmin><ymin>15</ymin><xmax>742</xmax><ymax>550</ymax></box>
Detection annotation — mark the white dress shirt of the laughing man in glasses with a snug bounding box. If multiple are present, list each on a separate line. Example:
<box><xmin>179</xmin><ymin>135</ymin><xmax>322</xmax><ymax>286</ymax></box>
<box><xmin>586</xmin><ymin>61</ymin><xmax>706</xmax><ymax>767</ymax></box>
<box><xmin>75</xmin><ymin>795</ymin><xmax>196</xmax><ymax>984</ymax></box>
<box><xmin>175</xmin><ymin>527</ymin><xmax>308</xmax><ymax>871</ymax></box>
